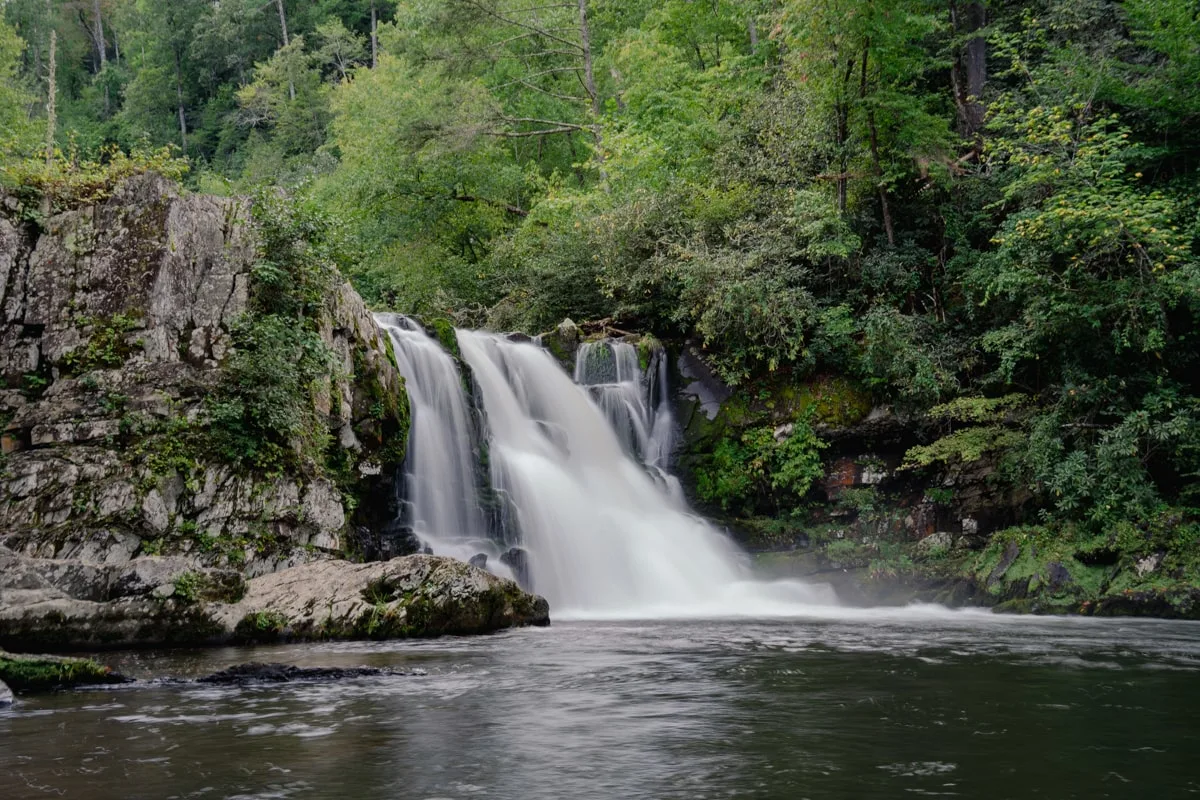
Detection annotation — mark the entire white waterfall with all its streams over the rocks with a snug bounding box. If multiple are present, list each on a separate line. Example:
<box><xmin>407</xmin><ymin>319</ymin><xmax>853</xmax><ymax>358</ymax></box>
<box><xmin>377</xmin><ymin>314</ymin><xmax>834</xmax><ymax>619</ymax></box>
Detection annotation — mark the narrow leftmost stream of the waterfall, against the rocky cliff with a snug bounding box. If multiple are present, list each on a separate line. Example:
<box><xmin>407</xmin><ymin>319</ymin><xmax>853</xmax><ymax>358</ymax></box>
<box><xmin>376</xmin><ymin>314</ymin><xmax>509</xmax><ymax>576</ymax></box>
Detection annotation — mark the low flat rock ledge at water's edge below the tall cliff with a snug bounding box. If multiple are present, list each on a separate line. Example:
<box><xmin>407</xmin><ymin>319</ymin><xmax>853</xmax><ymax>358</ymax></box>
<box><xmin>0</xmin><ymin>549</ymin><xmax>548</xmax><ymax>650</ymax></box>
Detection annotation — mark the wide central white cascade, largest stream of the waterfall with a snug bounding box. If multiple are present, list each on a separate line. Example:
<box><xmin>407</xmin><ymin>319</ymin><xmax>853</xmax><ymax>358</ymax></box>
<box><xmin>458</xmin><ymin>331</ymin><xmax>835</xmax><ymax>618</ymax></box>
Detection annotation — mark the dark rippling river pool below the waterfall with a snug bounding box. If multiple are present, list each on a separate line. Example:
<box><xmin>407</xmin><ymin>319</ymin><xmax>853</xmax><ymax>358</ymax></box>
<box><xmin>0</xmin><ymin>609</ymin><xmax>1200</xmax><ymax>800</ymax></box>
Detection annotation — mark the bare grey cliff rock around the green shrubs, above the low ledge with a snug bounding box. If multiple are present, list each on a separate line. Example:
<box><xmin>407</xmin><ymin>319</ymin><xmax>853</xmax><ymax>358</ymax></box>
<box><xmin>0</xmin><ymin>175</ymin><xmax>407</xmax><ymax>576</ymax></box>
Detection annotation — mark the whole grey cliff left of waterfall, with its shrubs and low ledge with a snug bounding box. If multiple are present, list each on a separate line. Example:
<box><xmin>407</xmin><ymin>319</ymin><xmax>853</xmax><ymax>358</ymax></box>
<box><xmin>0</xmin><ymin>175</ymin><xmax>545</xmax><ymax>646</ymax></box>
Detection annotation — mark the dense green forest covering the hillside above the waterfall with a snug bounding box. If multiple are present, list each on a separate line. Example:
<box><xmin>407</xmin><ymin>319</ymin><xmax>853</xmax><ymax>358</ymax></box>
<box><xmin>0</xmin><ymin>0</ymin><xmax>1200</xmax><ymax>542</ymax></box>
